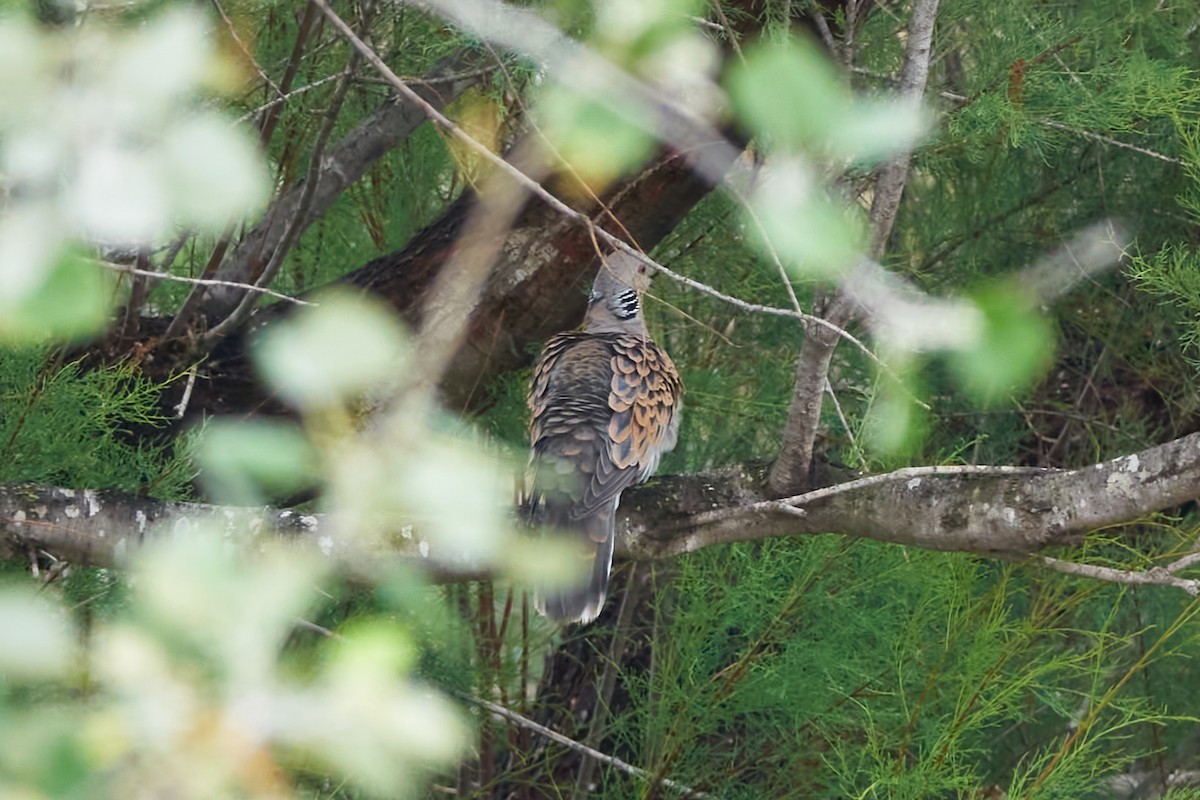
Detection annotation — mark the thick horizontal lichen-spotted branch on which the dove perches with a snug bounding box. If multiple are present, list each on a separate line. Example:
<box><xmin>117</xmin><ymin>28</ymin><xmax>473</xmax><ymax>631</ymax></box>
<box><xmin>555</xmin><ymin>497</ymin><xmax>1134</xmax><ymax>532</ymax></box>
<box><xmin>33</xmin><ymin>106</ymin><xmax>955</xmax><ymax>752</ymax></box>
<box><xmin>9</xmin><ymin>433</ymin><xmax>1200</xmax><ymax>579</ymax></box>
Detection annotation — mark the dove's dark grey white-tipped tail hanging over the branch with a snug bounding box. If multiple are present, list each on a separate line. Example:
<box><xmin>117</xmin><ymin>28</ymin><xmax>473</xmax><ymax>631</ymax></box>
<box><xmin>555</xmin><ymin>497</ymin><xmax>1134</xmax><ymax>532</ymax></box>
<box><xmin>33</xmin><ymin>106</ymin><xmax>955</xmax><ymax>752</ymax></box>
<box><xmin>535</xmin><ymin>503</ymin><xmax>617</xmax><ymax>625</ymax></box>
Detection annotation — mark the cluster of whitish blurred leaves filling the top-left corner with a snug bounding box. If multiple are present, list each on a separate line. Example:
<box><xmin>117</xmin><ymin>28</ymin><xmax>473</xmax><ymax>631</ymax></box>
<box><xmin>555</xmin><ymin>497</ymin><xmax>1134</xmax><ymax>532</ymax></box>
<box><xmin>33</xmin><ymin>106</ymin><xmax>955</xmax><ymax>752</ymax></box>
<box><xmin>0</xmin><ymin>6</ymin><xmax>269</xmax><ymax>266</ymax></box>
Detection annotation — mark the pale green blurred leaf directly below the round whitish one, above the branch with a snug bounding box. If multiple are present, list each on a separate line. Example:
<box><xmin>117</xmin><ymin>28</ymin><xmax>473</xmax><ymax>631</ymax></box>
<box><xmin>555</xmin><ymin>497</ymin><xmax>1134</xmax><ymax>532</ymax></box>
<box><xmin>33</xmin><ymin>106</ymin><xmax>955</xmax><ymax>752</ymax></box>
<box><xmin>197</xmin><ymin>420</ymin><xmax>319</xmax><ymax>506</ymax></box>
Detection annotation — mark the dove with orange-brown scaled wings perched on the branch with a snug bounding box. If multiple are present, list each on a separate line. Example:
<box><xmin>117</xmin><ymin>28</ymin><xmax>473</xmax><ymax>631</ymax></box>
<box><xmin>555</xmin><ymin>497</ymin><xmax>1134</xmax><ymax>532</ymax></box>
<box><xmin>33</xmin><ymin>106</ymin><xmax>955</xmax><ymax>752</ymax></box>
<box><xmin>527</xmin><ymin>253</ymin><xmax>683</xmax><ymax>624</ymax></box>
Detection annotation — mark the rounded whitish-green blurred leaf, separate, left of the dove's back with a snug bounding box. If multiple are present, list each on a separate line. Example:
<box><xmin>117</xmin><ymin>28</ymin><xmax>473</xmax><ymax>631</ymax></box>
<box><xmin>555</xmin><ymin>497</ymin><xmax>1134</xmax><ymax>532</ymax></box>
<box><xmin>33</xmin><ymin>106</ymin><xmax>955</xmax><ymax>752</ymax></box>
<box><xmin>254</xmin><ymin>293</ymin><xmax>407</xmax><ymax>410</ymax></box>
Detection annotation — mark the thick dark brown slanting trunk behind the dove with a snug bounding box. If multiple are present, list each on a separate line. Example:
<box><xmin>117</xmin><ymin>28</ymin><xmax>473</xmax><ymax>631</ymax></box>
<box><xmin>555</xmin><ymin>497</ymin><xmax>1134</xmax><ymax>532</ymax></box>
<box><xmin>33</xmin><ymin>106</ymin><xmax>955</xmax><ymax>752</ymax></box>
<box><xmin>176</xmin><ymin>143</ymin><xmax>720</xmax><ymax>414</ymax></box>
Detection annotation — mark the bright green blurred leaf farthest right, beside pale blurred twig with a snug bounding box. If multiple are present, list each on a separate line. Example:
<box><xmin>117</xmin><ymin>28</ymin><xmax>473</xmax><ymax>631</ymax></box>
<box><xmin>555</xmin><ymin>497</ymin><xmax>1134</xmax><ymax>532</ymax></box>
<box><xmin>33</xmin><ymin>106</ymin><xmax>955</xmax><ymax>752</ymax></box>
<box><xmin>947</xmin><ymin>283</ymin><xmax>1055</xmax><ymax>405</ymax></box>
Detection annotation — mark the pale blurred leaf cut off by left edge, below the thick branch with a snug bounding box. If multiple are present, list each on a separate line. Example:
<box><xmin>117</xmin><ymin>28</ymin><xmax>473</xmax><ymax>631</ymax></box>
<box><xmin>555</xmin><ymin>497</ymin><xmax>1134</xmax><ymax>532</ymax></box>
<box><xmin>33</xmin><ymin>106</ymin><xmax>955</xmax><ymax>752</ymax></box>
<box><xmin>0</xmin><ymin>587</ymin><xmax>71</xmax><ymax>680</ymax></box>
